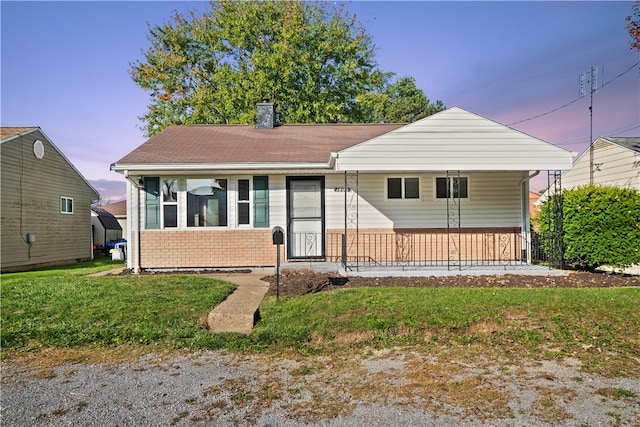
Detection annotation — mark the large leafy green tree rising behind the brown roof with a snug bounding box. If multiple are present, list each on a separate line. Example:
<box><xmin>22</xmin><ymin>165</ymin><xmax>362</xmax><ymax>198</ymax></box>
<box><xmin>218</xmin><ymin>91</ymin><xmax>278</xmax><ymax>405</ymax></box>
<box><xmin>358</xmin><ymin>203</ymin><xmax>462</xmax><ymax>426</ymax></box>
<box><xmin>131</xmin><ymin>1</ymin><xmax>442</xmax><ymax>136</ymax></box>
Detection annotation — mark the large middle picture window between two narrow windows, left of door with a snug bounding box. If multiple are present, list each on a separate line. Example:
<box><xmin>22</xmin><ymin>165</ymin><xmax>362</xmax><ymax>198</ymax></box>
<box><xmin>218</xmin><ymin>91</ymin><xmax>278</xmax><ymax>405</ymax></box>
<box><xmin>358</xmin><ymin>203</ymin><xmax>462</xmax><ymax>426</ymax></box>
<box><xmin>187</xmin><ymin>178</ymin><xmax>227</xmax><ymax>227</ymax></box>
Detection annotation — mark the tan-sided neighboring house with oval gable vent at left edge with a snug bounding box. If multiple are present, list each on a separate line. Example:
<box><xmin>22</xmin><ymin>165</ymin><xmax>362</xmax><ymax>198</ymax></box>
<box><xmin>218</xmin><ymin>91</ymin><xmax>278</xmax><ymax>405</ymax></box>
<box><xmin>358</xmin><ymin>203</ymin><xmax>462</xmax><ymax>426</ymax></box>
<box><xmin>0</xmin><ymin>127</ymin><xmax>100</xmax><ymax>272</ymax></box>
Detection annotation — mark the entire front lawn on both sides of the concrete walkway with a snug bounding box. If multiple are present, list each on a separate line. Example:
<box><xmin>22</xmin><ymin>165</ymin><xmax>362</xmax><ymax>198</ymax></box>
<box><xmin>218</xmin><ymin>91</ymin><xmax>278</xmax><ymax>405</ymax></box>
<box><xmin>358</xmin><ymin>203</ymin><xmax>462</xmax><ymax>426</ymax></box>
<box><xmin>1</xmin><ymin>260</ymin><xmax>640</xmax><ymax>377</ymax></box>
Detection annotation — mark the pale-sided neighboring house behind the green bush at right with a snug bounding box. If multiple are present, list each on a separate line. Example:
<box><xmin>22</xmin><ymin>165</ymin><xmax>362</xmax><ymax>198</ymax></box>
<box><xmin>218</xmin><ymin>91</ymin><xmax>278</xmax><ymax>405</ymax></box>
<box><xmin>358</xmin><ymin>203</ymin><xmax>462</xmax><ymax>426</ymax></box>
<box><xmin>561</xmin><ymin>136</ymin><xmax>640</xmax><ymax>190</ymax></box>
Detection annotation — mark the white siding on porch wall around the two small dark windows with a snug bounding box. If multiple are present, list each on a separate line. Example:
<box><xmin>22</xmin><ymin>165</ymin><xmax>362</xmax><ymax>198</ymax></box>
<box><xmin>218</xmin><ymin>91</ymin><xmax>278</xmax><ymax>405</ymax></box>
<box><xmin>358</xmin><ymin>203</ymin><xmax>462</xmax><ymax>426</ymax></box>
<box><xmin>326</xmin><ymin>172</ymin><xmax>526</xmax><ymax>229</ymax></box>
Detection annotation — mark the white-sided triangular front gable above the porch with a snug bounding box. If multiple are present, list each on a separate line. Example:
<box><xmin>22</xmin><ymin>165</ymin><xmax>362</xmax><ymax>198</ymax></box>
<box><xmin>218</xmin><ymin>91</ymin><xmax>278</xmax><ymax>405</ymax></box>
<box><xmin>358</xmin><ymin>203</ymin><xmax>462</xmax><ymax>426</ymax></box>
<box><xmin>336</xmin><ymin>107</ymin><xmax>572</xmax><ymax>171</ymax></box>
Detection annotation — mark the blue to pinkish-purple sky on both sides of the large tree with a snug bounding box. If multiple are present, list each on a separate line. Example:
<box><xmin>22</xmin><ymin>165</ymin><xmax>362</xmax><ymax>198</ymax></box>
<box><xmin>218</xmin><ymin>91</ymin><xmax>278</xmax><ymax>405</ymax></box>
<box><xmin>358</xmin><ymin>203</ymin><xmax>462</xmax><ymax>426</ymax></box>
<box><xmin>0</xmin><ymin>0</ymin><xmax>640</xmax><ymax>202</ymax></box>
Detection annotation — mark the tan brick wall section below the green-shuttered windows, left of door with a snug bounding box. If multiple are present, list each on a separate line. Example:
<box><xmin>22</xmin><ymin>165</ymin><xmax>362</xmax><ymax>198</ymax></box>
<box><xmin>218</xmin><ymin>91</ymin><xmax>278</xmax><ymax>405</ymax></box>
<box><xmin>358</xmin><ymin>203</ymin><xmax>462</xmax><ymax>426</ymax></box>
<box><xmin>140</xmin><ymin>229</ymin><xmax>284</xmax><ymax>269</ymax></box>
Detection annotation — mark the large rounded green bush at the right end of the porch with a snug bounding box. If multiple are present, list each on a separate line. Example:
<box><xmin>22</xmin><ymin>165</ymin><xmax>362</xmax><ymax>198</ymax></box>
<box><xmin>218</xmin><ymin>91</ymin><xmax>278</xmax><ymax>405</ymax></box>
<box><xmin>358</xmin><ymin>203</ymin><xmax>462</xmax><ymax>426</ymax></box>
<box><xmin>537</xmin><ymin>185</ymin><xmax>640</xmax><ymax>271</ymax></box>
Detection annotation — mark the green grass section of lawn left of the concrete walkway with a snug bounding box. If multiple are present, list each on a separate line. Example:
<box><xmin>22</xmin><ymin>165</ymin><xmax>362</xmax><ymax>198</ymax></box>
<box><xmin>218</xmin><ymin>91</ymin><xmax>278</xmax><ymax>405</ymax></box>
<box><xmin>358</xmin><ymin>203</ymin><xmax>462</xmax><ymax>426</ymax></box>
<box><xmin>1</xmin><ymin>265</ymin><xmax>235</xmax><ymax>358</ymax></box>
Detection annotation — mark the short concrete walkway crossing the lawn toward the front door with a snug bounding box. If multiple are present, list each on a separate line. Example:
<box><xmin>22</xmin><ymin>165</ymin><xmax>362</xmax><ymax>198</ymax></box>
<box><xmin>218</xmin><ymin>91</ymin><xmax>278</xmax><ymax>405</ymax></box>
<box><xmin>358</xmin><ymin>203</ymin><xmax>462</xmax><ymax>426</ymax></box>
<box><xmin>207</xmin><ymin>270</ymin><xmax>273</xmax><ymax>335</ymax></box>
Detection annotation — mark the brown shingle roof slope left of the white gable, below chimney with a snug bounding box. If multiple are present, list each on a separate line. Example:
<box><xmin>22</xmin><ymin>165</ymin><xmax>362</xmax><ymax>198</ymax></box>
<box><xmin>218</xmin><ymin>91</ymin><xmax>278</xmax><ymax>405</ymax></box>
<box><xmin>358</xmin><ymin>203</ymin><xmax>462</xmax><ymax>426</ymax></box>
<box><xmin>117</xmin><ymin>124</ymin><xmax>403</xmax><ymax>164</ymax></box>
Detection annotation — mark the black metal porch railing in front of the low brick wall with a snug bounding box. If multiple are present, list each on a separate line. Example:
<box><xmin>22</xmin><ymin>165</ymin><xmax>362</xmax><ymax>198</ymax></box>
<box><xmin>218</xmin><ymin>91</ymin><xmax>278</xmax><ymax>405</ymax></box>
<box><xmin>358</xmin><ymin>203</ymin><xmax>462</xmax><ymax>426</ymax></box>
<box><xmin>326</xmin><ymin>232</ymin><xmax>535</xmax><ymax>267</ymax></box>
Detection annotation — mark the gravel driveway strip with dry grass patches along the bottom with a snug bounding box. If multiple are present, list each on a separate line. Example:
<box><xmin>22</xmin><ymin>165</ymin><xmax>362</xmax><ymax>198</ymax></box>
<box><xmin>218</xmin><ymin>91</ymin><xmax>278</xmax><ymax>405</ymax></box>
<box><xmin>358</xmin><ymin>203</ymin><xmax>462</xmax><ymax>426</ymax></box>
<box><xmin>0</xmin><ymin>350</ymin><xmax>640</xmax><ymax>426</ymax></box>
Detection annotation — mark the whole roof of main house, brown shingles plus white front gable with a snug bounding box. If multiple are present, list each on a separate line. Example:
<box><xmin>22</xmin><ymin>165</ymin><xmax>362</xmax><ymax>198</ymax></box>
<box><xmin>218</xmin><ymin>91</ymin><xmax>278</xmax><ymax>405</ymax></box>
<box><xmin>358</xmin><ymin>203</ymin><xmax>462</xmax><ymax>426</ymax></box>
<box><xmin>111</xmin><ymin>107</ymin><xmax>572</xmax><ymax>174</ymax></box>
